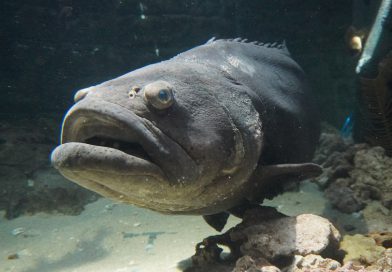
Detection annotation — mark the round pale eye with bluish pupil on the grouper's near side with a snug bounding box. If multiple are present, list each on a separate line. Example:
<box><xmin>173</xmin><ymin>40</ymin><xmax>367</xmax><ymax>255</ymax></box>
<box><xmin>143</xmin><ymin>81</ymin><xmax>174</xmax><ymax>110</ymax></box>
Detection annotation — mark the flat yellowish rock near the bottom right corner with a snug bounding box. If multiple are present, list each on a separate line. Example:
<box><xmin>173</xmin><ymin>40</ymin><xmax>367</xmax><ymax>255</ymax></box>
<box><xmin>340</xmin><ymin>234</ymin><xmax>385</xmax><ymax>266</ymax></box>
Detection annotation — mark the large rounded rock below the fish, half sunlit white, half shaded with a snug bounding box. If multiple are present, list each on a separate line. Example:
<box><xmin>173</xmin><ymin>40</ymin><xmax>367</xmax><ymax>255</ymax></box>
<box><xmin>231</xmin><ymin>214</ymin><xmax>340</xmax><ymax>261</ymax></box>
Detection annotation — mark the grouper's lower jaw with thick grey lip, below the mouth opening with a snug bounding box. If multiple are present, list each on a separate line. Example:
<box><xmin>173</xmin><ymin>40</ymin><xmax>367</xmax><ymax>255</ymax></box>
<box><xmin>51</xmin><ymin>142</ymin><xmax>170</xmax><ymax>202</ymax></box>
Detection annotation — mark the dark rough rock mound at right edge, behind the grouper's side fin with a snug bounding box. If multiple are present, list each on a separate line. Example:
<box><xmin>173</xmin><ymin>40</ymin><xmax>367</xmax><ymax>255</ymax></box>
<box><xmin>314</xmin><ymin>126</ymin><xmax>392</xmax><ymax>213</ymax></box>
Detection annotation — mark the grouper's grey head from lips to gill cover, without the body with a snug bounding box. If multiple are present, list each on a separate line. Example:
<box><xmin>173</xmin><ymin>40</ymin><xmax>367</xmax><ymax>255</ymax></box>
<box><xmin>51</xmin><ymin>61</ymin><xmax>260</xmax><ymax>214</ymax></box>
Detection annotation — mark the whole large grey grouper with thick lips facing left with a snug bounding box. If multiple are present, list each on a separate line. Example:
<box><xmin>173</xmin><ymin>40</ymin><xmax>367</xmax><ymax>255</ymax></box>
<box><xmin>51</xmin><ymin>39</ymin><xmax>321</xmax><ymax>230</ymax></box>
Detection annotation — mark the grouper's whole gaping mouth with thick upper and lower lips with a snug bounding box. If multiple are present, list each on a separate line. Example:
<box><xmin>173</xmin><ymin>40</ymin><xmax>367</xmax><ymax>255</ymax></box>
<box><xmin>51</xmin><ymin>99</ymin><xmax>197</xmax><ymax>210</ymax></box>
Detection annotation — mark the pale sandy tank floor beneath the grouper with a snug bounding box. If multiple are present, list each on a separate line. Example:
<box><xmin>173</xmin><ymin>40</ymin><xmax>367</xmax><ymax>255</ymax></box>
<box><xmin>0</xmin><ymin>183</ymin><xmax>391</xmax><ymax>272</ymax></box>
